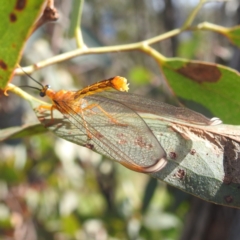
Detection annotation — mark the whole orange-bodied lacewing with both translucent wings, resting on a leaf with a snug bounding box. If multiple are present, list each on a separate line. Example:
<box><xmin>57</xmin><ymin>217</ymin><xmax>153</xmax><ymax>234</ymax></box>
<box><xmin>23</xmin><ymin>76</ymin><xmax>221</xmax><ymax>173</ymax></box>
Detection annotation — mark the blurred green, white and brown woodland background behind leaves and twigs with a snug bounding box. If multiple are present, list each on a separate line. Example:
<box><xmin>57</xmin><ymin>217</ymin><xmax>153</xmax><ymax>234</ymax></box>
<box><xmin>0</xmin><ymin>0</ymin><xmax>240</xmax><ymax>240</ymax></box>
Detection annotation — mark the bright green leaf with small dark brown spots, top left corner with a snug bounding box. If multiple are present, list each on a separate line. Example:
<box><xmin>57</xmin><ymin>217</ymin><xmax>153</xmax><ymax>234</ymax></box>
<box><xmin>0</xmin><ymin>0</ymin><xmax>45</xmax><ymax>89</ymax></box>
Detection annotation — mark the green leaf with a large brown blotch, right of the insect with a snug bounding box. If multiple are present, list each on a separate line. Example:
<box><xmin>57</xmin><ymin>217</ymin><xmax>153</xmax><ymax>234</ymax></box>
<box><xmin>161</xmin><ymin>58</ymin><xmax>240</xmax><ymax>124</ymax></box>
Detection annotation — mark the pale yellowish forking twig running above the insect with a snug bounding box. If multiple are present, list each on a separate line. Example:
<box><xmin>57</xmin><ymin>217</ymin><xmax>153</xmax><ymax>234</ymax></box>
<box><xmin>15</xmin><ymin>0</ymin><xmax>226</xmax><ymax>75</ymax></box>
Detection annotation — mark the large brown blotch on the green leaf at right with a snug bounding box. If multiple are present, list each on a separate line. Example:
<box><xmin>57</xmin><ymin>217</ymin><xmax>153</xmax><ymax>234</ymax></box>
<box><xmin>177</xmin><ymin>63</ymin><xmax>221</xmax><ymax>83</ymax></box>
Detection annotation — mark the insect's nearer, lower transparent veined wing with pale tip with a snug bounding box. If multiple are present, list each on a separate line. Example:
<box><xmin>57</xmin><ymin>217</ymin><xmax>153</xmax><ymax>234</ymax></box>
<box><xmin>37</xmin><ymin>94</ymin><xmax>166</xmax><ymax>172</ymax></box>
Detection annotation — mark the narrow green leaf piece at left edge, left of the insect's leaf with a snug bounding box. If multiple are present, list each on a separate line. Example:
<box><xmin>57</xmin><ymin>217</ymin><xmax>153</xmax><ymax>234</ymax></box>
<box><xmin>0</xmin><ymin>123</ymin><xmax>48</xmax><ymax>141</ymax></box>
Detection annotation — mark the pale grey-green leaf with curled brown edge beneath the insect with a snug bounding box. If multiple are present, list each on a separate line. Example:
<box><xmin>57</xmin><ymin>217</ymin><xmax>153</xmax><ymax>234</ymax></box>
<box><xmin>36</xmin><ymin>101</ymin><xmax>240</xmax><ymax>208</ymax></box>
